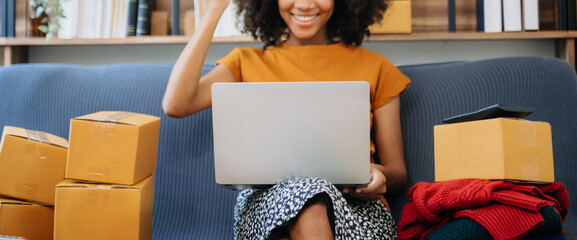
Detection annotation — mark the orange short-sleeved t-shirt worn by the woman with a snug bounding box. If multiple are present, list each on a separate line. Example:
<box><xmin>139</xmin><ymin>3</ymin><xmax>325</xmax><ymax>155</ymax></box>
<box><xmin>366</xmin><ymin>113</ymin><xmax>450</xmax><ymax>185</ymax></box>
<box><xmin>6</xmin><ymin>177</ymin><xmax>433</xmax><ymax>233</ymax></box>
<box><xmin>216</xmin><ymin>43</ymin><xmax>410</xmax><ymax>158</ymax></box>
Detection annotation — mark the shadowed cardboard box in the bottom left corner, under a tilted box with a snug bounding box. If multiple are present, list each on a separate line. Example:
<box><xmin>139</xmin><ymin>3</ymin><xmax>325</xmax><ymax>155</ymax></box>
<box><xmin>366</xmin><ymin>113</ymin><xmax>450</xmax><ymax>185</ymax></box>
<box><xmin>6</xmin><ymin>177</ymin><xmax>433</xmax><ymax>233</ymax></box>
<box><xmin>0</xmin><ymin>198</ymin><xmax>54</xmax><ymax>240</ymax></box>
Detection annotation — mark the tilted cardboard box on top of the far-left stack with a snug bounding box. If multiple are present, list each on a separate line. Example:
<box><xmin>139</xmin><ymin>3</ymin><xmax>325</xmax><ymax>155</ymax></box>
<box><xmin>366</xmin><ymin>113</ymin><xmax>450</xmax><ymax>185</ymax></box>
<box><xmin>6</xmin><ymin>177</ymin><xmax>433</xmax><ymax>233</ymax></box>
<box><xmin>0</xmin><ymin>126</ymin><xmax>68</xmax><ymax>205</ymax></box>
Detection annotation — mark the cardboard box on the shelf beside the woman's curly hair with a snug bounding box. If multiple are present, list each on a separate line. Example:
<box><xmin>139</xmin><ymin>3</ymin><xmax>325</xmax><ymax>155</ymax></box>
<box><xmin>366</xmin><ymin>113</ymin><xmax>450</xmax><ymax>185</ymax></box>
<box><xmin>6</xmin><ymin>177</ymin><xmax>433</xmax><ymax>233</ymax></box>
<box><xmin>369</xmin><ymin>0</ymin><xmax>412</xmax><ymax>34</ymax></box>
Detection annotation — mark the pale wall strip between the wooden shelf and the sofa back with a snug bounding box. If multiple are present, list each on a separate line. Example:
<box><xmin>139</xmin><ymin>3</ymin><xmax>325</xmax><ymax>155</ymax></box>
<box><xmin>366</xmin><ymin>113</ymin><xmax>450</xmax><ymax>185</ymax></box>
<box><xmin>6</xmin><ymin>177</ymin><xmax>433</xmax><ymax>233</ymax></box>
<box><xmin>29</xmin><ymin>39</ymin><xmax>555</xmax><ymax>65</ymax></box>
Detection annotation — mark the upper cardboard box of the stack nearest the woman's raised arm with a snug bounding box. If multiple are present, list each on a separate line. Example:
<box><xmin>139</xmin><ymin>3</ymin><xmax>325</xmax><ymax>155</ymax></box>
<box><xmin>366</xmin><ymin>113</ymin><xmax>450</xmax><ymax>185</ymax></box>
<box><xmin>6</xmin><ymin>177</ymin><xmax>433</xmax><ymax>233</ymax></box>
<box><xmin>66</xmin><ymin>112</ymin><xmax>160</xmax><ymax>185</ymax></box>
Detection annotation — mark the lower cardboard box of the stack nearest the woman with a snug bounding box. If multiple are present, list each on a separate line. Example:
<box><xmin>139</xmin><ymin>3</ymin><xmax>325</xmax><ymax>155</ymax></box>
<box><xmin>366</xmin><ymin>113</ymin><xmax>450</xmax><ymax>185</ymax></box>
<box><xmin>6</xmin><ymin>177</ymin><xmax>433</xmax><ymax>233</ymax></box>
<box><xmin>54</xmin><ymin>176</ymin><xmax>154</xmax><ymax>240</ymax></box>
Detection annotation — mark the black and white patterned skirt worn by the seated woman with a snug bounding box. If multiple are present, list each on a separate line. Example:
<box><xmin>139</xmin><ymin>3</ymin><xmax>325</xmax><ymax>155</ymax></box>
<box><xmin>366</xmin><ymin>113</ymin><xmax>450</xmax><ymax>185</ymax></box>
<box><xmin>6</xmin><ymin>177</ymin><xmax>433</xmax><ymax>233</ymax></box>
<box><xmin>234</xmin><ymin>178</ymin><xmax>397</xmax><ymax>239</ymax></box>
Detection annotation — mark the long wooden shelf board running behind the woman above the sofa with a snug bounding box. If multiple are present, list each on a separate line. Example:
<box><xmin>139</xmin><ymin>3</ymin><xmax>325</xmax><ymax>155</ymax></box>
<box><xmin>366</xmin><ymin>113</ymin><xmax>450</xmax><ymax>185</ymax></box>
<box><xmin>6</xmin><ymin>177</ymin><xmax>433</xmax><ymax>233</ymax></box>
<box><xmin>0</xmin><ymin>31</ymin><xmax>577</xmax><ymax>46</ymax></box>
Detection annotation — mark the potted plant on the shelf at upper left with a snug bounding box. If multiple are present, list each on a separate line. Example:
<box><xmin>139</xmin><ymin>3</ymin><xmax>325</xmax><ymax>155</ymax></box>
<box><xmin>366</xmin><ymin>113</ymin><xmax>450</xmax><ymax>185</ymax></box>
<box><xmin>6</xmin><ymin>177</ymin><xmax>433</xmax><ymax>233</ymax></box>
<box><xmin>29</xmin><ymin>0</ymin><xmax>65</xmax><ymax>40</ymax></box>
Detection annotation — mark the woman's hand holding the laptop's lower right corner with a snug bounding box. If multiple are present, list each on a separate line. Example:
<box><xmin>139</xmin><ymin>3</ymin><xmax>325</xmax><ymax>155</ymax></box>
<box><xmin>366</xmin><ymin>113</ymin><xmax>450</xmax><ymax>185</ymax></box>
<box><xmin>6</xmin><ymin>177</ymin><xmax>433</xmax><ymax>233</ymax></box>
<box><xmin>341</xmin><ymin>163</ymin><xmax>387</xmax><ymax>201</ymax></box>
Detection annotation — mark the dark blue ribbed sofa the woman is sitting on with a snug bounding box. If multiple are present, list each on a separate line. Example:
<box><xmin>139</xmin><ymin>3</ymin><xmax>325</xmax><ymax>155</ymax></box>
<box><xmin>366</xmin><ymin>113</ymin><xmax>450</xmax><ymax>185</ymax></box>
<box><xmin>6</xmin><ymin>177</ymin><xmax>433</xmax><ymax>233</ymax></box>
<box><xmin>0</xmin><ymin>57</ymin><xmax>577</xmax><ymax>239</ymax></box>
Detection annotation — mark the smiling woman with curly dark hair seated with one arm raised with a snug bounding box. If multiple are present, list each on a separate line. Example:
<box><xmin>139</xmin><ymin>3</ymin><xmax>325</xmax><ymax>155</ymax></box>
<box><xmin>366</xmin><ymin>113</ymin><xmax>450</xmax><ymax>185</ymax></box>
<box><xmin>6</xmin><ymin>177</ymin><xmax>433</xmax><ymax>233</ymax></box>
<box><xmin>163</xmin><ymin>0</ymin><xmax>410</xmax><ymax>239</ymax></box>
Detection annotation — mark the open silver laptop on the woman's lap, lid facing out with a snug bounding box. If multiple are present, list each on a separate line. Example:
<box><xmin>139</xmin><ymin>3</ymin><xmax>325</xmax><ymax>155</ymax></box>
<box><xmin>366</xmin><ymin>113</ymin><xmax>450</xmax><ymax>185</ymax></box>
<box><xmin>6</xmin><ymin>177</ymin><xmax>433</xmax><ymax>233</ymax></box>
<box><xmin>212</xmin><ymin>82</ymin><xmax>370</xmax><ymax>189</ymax></box>
